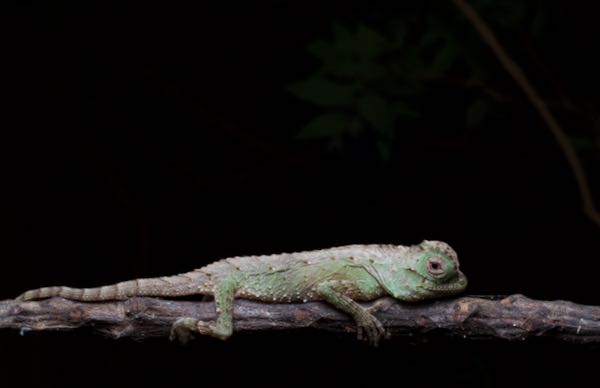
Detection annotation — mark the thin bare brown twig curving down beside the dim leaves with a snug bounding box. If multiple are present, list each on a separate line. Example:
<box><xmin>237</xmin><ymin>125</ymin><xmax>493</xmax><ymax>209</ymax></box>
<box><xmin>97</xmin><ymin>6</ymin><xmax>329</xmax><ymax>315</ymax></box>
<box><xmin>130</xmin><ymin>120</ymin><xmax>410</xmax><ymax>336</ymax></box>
<box><xmin>454</xmin><ymin>0</ymin><xmax>600</xmax><ymax>226</ymax></box>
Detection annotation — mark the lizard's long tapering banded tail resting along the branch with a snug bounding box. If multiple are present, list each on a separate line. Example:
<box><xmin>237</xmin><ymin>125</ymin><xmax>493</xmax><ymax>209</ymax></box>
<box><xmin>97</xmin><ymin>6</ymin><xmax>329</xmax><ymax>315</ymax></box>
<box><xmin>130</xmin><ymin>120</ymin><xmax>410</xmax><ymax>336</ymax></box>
<box><xmin>17</xmin><ymin>271</ymin><xmax>209</xmax><ymax>302</ymax></box>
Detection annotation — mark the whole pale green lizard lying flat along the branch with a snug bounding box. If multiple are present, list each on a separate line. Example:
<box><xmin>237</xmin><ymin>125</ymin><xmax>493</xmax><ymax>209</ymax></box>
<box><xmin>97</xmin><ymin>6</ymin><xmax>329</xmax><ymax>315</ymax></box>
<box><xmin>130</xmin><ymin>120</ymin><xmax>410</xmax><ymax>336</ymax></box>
<box><xmin>12</xmin><ymin>240</ymin><xmax>467</xmax><ymax>345</ymax></box>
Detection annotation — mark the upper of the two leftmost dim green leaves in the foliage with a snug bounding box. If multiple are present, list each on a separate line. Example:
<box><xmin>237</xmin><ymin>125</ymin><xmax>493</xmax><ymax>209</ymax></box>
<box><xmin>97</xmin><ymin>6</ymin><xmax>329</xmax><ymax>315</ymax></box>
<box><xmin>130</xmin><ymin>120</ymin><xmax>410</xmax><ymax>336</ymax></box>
<box><xmin>287</xmin><ymin>76</ymin><xmax>355</xmax><ymax>107</ymax></box>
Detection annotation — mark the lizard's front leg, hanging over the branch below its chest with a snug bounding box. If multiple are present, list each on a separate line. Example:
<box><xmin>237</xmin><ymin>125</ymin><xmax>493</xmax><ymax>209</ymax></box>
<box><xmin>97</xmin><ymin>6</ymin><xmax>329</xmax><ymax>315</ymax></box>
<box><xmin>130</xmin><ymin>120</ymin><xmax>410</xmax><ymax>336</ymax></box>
<box><xmin>317</xmin><ymin>280</ymin><xmax>385</xmax><ymax>346</ymax></box>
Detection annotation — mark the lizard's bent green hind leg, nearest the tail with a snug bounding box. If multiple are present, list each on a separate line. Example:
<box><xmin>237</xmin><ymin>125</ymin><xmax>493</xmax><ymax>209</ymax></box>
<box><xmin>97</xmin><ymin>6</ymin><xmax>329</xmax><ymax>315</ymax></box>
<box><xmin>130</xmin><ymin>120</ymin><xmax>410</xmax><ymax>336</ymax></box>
<box><xmin>170</xmin><ymin>278</ymin><xmax>238</xmax><ymax>343</ymax></box>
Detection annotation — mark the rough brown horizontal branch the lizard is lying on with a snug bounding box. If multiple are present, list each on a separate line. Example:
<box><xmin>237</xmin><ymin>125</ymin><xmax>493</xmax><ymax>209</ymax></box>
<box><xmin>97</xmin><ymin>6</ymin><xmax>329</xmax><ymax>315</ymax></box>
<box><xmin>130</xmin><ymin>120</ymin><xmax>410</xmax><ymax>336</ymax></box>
<box><xmin>0</xmin><ymin>295</ymin><xmax>600</xmax><ymax>343</ymax></box>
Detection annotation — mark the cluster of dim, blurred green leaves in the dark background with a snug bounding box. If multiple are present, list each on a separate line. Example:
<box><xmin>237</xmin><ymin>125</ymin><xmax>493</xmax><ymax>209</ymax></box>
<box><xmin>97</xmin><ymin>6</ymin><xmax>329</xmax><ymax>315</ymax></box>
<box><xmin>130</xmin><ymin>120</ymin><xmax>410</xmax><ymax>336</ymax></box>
<box><xmin>287</xmin><ymin>0</ymin><xmax>556</xmax><ymax>159</ymax></box>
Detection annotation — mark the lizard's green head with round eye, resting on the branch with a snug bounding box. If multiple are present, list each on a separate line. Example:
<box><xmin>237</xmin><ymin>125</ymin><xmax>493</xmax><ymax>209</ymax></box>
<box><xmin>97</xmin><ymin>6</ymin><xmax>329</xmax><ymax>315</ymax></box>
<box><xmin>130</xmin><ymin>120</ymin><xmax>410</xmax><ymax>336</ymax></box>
<box><xmin>407</xmin><ymin>241</ymin><xmax>467</xmax><ymax>300</ymax></box>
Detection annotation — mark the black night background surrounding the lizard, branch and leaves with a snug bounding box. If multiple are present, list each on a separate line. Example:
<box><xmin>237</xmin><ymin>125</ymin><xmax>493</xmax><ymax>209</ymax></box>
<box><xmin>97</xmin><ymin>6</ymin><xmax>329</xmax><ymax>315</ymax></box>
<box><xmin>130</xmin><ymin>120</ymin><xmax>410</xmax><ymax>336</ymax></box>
<box><xmin>0</xmin><ymin>1</ymin><xmax>600</xmax><ymax>387</ymax></box>
